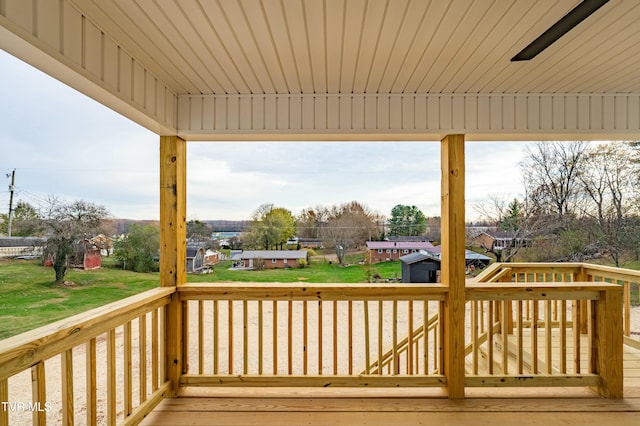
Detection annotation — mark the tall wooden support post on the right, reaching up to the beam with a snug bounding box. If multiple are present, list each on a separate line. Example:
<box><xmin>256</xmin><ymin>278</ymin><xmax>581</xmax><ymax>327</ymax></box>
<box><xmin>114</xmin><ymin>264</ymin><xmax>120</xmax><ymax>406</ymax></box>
<box><xmin>441</xmin><ymin>135</ymin><xmax>465</xmax><ymax>399</ymax></box>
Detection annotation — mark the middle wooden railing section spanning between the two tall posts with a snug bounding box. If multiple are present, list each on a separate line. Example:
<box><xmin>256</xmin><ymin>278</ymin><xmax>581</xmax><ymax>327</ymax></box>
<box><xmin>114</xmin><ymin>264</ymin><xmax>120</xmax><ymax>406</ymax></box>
<box><xmin>179</xmin><ymin>284</ymin><xmax>447</xmax><ymax>387</ymax></box>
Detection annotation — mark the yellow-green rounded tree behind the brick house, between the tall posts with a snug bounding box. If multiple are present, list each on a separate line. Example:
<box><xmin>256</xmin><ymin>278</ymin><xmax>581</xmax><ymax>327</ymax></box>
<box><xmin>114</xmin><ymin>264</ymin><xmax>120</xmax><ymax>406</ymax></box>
<box><xmin>245</xmin><ymin>204</ymin><xmax>296</xmax><ymax>250</ymax></box>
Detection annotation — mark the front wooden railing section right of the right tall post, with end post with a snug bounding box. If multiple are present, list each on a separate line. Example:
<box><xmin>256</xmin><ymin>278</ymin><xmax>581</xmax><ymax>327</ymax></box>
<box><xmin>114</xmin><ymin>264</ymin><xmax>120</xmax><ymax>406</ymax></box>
<box><xmin>465</xmin><ymin>283</ymin><xmax>622</xmax><ymax>397</ymax></box>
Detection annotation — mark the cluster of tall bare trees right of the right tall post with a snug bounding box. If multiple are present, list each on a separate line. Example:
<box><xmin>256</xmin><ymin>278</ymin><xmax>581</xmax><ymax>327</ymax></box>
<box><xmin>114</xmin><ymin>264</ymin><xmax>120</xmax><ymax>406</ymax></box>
<box><xmin>478</xmin><ymin>141</ymin><xmax>640</xmax><ymax>266</ymax></box>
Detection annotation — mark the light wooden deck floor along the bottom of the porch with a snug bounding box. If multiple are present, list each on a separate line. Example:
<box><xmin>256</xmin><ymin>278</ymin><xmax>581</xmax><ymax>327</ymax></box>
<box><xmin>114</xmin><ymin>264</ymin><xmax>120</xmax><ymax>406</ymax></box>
<box><xmin>142</xmin><ymin>346</ymin><xmax>640</xmax><ymax>426</ymax></box>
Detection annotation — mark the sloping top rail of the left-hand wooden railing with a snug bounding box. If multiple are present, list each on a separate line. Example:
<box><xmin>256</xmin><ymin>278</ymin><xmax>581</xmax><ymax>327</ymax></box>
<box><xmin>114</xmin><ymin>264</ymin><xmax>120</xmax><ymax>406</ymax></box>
<box><xmin>0</xmin><ymin>287</ymin><xmax>176</xmax><ymax>379</ymax></box>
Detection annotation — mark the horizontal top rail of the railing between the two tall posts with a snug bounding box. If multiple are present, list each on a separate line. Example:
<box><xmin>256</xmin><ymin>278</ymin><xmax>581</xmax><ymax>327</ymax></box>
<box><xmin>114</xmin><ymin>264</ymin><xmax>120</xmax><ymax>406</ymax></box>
<box><xmin>178</xmin><ymin>283</ymin><xmax>449</xmax><ymax>300</ymax></box>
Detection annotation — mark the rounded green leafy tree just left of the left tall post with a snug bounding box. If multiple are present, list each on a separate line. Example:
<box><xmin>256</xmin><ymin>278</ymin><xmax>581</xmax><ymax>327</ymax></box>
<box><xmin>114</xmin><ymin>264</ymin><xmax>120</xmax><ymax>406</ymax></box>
<box><xmin>113</xmin><ymin>223</ymin><xmax>160</xmax><ymax>272</ymax></box>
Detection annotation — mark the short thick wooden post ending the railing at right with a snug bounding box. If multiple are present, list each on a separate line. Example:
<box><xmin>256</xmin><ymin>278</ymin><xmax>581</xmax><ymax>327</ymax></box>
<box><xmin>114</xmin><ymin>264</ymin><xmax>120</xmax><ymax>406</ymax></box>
<box><xmin>593</xmin><ymin>287</ymin><xmax>624</xmax><ymax>398</ymax></box>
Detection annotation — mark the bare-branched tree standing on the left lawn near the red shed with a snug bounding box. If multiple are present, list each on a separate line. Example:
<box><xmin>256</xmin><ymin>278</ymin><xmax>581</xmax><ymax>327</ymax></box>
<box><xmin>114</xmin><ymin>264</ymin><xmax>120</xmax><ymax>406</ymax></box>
<box><xmin>42</xmin><ymin>197</ymin><xmax>109</xmax><ymax>284</ymax></box>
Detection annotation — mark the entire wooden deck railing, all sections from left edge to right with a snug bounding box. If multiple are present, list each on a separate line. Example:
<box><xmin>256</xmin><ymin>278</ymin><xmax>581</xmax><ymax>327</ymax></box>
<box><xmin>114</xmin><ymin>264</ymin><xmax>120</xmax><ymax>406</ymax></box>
<box><xmin>0</xmin><ymin>264</ymin><xmax>640</xmax><ymax>425</ymax></box>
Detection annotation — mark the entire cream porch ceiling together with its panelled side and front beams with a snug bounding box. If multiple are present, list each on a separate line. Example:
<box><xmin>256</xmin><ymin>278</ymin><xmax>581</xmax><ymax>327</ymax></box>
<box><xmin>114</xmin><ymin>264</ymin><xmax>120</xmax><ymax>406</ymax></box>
<box><xmin>0</xmin><ymin>0</ymin><xmax>640</xmax><ymax>140</ymax></box>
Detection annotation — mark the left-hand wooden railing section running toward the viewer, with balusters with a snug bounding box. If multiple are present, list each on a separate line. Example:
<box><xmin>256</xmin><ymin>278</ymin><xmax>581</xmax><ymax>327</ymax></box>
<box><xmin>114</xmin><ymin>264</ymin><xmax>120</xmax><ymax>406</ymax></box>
<box><xmin>0</xmin><ymin>288</ymin><xmax>175</xmax><ymax>425</ymax></box>
